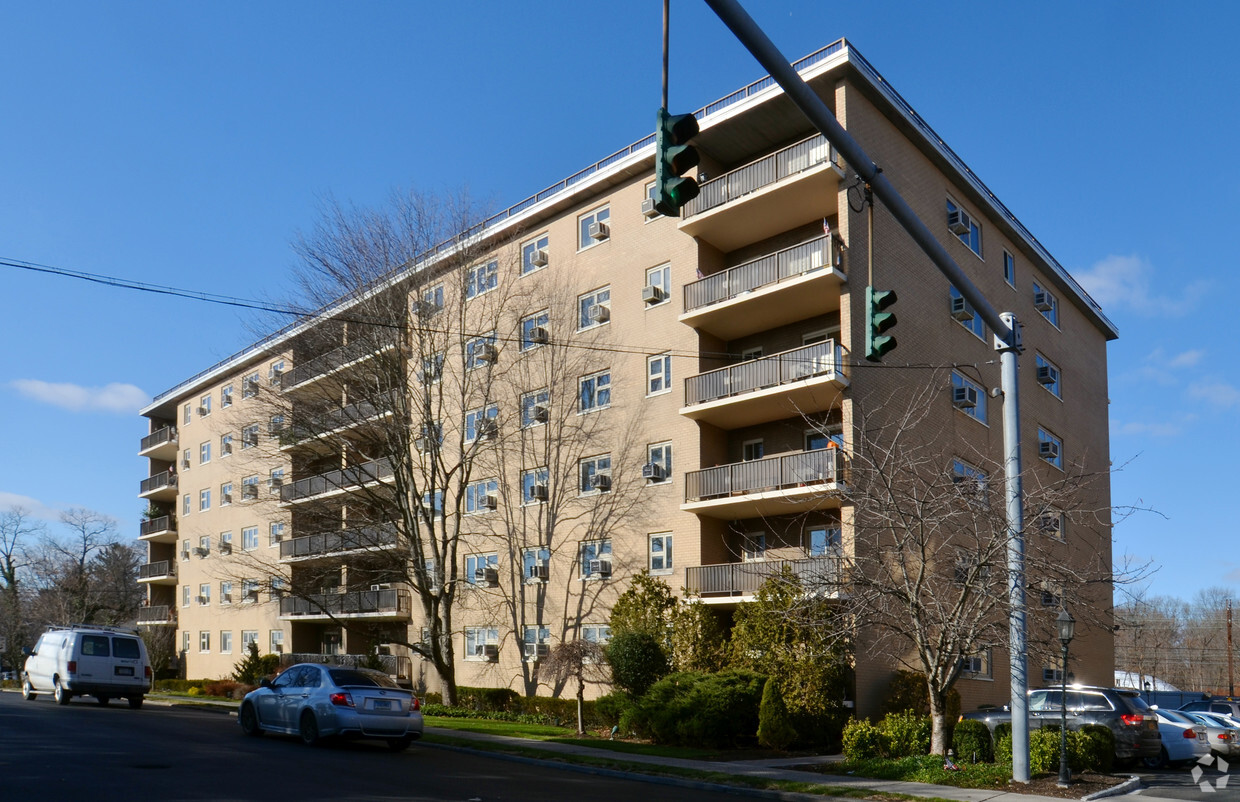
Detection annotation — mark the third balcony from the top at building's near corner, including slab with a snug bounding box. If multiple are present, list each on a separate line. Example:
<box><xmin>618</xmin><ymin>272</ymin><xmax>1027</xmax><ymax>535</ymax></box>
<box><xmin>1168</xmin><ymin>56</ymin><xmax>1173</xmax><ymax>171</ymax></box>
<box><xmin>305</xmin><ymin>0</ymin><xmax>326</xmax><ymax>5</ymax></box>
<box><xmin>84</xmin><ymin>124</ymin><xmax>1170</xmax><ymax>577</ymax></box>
<box><xmin>681</xmin><ymin>340</ymin><xmax>848</xmax><ymax>429</ymax></box>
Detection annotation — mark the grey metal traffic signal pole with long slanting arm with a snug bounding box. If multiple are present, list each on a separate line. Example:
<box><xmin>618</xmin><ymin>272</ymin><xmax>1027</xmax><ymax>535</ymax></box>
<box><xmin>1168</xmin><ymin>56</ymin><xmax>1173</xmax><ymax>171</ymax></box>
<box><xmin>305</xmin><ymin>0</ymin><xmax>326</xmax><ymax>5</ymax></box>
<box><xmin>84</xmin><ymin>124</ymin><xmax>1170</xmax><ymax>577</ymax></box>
<box><xmin>706</xmin><ymin>0</ymin><xmax>1029</xmax><ymax>782</ymax></box>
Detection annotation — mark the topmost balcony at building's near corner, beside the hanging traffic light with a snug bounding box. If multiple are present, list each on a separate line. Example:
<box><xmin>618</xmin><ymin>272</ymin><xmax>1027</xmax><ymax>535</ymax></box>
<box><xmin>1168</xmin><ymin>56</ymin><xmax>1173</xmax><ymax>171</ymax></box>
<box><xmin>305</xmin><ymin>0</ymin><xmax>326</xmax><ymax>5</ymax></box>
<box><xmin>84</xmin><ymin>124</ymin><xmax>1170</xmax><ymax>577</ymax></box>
<box><xmin>680</xmin><ymin>136</ymin><xmax>843</xmax><ymax>253</ymax></box>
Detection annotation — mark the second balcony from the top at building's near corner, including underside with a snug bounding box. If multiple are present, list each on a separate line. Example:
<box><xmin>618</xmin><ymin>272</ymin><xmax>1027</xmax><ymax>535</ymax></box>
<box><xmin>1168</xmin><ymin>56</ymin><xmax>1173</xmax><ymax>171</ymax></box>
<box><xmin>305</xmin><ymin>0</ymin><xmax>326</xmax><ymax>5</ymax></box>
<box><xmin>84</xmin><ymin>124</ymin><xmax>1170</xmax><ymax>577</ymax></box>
<box><xmin>680</xmin><ymin>237</ymin><xmax>846</xmax><ymax>340</ymax></box>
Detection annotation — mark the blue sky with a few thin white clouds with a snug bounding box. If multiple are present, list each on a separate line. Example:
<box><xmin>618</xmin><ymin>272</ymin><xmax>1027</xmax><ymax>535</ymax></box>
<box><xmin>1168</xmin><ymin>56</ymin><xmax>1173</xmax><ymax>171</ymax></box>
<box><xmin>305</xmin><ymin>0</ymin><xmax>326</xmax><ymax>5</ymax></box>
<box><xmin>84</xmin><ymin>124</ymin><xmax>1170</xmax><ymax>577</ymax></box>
<box><xmin>0</xmin><ymin>0</ymin><xmax>1240</xmax><ymax>599</ymax></box>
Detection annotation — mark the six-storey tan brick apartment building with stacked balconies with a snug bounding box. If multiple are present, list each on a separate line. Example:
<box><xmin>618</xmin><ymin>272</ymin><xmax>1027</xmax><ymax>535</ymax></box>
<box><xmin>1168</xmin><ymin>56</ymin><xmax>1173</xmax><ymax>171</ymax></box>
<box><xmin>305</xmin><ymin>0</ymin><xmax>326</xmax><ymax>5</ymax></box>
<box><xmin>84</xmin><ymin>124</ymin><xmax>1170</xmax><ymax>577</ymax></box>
<box><xmin>140</xmin><ymin>40</ymin><xmax>1117</xmax><ymax>713</ymax></box>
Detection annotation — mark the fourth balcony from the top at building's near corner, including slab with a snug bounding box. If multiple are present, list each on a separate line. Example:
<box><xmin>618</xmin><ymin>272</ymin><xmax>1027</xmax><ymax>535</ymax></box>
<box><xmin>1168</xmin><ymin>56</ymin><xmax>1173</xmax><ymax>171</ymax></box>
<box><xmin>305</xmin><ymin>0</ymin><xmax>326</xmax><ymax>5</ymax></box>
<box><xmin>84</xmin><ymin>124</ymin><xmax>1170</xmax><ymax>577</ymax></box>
<box><xmin>681</xmin><ymin>449</ymin><xmax>843</xmax><ymax>521</ymax></box>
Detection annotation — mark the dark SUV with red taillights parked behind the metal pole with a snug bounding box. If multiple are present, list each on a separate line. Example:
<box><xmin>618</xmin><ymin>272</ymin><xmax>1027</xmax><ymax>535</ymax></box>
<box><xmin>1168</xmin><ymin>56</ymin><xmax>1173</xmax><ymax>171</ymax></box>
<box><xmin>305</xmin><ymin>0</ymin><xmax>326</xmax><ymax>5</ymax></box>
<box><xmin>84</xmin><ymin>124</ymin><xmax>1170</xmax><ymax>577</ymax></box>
<box><xmin>960</xmin><ymin>685</ymin><xmax>1162</xmax><ymax>760</ymax></box>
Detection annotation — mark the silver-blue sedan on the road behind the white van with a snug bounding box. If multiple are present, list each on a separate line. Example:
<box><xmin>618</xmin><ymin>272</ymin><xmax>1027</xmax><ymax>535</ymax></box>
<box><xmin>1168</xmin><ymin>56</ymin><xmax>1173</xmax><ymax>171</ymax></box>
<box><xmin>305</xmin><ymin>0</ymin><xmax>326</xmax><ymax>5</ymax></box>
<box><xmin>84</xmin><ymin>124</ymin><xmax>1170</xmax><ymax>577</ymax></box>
<box><xmin>237</xmin><ymin>663</ymin><xmax>423</xmax><ymax>751</ymax></box>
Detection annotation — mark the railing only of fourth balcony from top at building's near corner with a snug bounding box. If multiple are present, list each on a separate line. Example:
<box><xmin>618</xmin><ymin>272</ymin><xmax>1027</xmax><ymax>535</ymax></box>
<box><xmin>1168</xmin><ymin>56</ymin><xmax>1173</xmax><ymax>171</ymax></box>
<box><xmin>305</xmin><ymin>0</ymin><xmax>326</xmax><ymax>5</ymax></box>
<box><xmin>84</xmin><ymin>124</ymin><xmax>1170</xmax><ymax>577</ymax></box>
<box><xmin>684</xmin><ymin>449</ymin><xmax>842</xmax><ymax>503</ymax></box>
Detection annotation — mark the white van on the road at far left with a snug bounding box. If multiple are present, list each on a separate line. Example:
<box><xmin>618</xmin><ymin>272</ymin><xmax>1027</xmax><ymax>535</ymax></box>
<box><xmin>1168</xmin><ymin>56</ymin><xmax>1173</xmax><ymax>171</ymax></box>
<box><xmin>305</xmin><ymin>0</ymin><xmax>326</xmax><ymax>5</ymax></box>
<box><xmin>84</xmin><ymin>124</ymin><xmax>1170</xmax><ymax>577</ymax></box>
<box><xmin>21</xmin><ymin>625</ymin><xmax>151</xmax><ymax>710</ymax></box>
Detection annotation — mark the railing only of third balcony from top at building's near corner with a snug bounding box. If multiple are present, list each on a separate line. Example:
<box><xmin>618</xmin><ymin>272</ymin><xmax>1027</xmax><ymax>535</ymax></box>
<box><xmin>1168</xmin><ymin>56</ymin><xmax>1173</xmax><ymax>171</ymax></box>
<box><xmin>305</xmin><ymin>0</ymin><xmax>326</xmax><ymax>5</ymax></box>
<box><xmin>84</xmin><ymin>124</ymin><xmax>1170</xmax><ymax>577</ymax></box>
<box><xmin>684</xmin><ymin>340</ymin><xmax>844</xmax><ymax>407</ymax></box>
